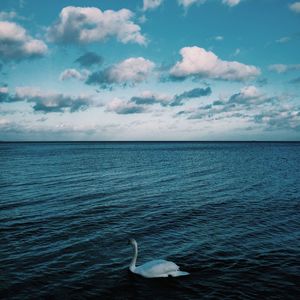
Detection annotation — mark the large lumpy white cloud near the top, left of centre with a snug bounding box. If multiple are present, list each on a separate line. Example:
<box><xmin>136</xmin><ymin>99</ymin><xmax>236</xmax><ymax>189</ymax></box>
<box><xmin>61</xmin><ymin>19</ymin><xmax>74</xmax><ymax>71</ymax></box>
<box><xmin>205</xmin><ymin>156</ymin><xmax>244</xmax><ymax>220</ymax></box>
<box><xmin>47</xmin><ymin>6</ymin><xmax>146</xmax><ymax>45</ymax></box>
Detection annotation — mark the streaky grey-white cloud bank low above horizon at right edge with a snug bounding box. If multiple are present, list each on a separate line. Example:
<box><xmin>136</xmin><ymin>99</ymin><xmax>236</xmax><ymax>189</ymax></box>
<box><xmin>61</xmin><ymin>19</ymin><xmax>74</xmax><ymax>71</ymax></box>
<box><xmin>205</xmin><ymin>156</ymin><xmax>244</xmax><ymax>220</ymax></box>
<box><xmin>177</xmin><ymin>86</ymin><xmax>300</xmax><ymax>131</ymax></box>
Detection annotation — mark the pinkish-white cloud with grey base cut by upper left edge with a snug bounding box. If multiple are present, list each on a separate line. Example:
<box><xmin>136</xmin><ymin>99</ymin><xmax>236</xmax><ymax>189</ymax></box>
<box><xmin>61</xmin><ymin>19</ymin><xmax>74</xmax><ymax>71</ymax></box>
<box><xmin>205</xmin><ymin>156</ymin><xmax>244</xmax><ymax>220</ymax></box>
<box><xmin>0</xmin><ymin>21</ymin><xmax>48</xmax><ymax>60</ymax></box>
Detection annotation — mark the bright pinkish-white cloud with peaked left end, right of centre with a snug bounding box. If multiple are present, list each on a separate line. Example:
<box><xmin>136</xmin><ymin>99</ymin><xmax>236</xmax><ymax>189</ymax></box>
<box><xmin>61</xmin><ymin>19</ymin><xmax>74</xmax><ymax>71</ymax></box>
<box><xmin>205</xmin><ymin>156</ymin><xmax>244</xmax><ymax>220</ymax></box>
<box><xmin>170</xmin><ymin>46</ymin><xmax>260</xmax><ymax>80</ymax></box>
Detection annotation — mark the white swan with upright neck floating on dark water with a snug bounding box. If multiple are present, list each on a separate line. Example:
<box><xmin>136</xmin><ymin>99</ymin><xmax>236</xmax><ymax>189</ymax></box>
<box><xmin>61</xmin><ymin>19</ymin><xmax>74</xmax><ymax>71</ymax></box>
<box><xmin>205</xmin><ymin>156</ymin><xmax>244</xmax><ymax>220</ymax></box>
<box><xmin>129</xmin><ymin>239</ymin><xmax>189</xmax><ymax>278</ymax></box>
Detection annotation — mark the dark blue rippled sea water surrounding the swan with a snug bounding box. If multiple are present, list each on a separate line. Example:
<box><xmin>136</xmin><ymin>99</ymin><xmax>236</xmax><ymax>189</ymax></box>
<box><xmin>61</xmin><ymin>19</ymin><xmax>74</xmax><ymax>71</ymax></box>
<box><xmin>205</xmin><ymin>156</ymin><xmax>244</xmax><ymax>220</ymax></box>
<box><xmin>0</xmin><ymin>143</ymin><xmax>300</xmax><ymax>299</ymax></box>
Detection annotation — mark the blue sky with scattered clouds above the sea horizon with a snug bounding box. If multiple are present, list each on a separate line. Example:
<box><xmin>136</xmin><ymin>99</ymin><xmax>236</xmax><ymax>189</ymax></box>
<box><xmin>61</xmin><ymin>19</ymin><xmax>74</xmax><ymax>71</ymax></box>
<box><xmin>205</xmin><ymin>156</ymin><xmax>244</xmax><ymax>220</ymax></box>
<box><xmin>0</xmin><ymin>0</ymin><xmax>300</xmax><ymax>141</ymax></box>
